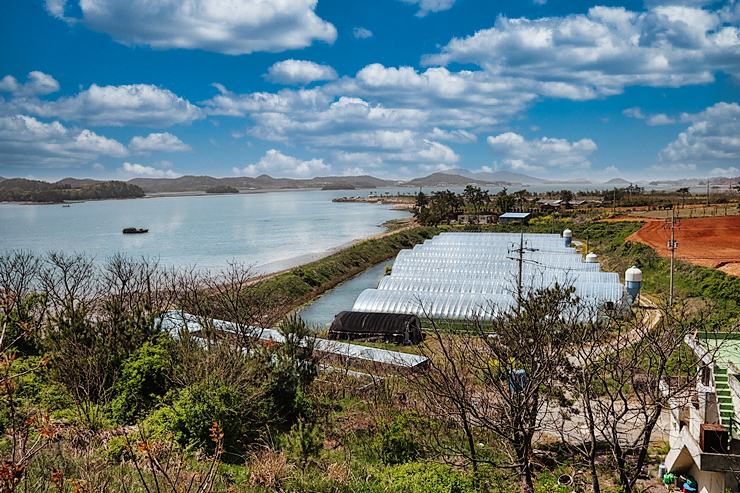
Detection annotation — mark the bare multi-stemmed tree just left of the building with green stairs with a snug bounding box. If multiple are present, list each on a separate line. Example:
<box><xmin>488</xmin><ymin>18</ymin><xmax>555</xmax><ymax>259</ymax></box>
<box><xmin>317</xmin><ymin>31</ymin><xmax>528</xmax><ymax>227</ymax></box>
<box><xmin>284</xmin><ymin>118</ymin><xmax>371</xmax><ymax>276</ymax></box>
<box><xmin>565</xmin><ymin>296</ymin><xmax>720</xmax><ymax>493</ymax></box>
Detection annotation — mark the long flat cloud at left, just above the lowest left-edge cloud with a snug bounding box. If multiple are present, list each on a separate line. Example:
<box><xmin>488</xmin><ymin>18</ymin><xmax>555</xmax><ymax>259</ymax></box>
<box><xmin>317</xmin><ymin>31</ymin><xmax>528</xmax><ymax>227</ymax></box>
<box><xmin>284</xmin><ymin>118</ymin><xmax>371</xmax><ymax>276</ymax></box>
<box><xmin>0</xmin><ymin>84</ymin><xmax>205</xmax><ymax>127</ymax></box>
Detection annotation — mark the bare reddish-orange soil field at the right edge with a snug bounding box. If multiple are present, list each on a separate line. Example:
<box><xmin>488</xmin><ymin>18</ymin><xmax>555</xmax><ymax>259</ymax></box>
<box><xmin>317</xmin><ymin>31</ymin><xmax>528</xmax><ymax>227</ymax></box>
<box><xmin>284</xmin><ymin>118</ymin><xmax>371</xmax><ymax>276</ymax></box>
<box><xmin>627</xmin><ymin>216</ymin><xmax>740</xmax><ymax>276</ymax></box>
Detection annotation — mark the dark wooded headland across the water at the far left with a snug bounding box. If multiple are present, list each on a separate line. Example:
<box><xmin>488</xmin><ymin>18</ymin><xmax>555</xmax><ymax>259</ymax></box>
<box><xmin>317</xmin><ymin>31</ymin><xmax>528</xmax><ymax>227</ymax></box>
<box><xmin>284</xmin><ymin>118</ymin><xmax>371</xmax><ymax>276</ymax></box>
<box><xmin>0</xmin><ymin>178</ymin><xmax>144</xmax><ymax>202</ymax></box>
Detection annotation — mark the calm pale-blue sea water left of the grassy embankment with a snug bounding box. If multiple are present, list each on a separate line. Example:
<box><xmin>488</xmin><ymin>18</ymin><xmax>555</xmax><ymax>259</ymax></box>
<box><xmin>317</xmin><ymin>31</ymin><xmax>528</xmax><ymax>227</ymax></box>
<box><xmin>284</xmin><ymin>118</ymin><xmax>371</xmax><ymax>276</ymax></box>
<box><xmin>0</xmin><ymin>191</ymin><xmax>410</xmax><ymax>272</ymax></box>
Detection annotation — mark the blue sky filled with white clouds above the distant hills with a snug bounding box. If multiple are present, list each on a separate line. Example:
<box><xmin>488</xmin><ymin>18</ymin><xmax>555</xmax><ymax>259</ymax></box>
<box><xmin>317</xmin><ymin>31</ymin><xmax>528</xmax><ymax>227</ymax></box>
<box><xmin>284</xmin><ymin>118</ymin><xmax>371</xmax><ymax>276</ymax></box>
<box><xmin>0</xmin><ymin>0</ymin><xmax>740</xmax><ymax>182</ymax></box>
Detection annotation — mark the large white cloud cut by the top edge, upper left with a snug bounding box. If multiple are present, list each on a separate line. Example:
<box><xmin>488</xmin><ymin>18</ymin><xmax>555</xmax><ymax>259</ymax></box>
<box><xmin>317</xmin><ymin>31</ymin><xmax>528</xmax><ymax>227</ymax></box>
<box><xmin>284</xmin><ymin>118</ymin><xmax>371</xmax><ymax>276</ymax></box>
<box><xmin>46</xmin><ymin>0</ymin><xmax>337</xmax><ymax>55</ymax></box>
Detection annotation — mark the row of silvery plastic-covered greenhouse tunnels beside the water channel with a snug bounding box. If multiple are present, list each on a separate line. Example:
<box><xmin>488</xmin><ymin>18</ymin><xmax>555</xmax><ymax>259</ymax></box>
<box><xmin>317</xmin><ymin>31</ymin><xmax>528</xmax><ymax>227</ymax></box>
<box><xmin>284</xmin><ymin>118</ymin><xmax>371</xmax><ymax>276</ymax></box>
<box><xmin>353</xmin><ymin>233</ymin><xmax>625</xmax><ymax>319</ymax></box>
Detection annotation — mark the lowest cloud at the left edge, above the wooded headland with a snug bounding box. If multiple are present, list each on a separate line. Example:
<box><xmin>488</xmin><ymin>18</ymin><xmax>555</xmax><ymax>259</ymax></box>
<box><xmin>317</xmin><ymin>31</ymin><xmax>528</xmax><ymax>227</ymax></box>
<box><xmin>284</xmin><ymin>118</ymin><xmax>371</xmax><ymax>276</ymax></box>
<box><xmin>0</xmin><ymin>115</ymin><xmax>129</xmax><ymax>168</ymax></box>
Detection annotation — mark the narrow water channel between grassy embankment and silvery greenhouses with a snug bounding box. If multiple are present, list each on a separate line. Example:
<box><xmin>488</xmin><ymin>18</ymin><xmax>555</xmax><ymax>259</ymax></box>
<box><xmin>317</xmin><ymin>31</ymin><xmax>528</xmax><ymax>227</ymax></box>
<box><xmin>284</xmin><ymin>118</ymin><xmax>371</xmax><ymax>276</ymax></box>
<box><xmin>298</xmin><ymin>259</ymin><xmax>395</xmax><ymax>329</ymax></box>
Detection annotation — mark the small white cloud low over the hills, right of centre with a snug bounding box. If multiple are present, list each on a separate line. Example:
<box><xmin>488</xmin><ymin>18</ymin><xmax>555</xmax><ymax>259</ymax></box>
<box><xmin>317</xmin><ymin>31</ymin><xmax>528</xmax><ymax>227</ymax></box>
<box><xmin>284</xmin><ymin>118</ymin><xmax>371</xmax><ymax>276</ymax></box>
<box><xmin>487</xmin><ymin>132</ymin><xmax>597</xmax><ymax>171</ymax></box>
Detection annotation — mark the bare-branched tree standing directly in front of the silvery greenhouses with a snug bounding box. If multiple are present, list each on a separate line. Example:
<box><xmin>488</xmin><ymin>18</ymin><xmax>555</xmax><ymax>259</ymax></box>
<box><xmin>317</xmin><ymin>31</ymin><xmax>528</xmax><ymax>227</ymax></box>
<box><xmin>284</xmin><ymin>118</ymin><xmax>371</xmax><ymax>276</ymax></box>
<box><xmin>414</xmin><ymin>285</ymin><xmax>582</xmax><ymax>493</ymax></box>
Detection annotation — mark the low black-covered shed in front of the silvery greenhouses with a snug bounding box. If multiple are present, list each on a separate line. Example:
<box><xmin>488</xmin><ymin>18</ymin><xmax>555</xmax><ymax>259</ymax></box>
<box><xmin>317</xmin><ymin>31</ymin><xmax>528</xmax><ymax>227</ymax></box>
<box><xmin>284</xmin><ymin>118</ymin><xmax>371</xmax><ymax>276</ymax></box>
<box><xmin>329</xmin><ymin>311</ymin><xmax>423</xmax><ymax>344</ymax></box>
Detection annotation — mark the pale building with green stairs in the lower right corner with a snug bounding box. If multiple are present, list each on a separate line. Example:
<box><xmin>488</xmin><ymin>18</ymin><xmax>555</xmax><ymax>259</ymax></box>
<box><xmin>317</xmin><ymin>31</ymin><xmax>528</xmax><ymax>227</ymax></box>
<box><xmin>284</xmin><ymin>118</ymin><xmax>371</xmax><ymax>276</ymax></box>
<box><xmin>665</xmin><ymin>332</ymin><xmax>740</xmax><ymax>493</ymax></box>
